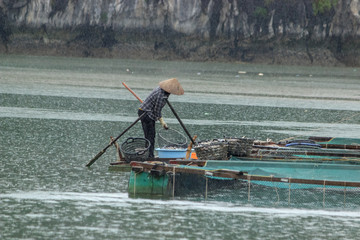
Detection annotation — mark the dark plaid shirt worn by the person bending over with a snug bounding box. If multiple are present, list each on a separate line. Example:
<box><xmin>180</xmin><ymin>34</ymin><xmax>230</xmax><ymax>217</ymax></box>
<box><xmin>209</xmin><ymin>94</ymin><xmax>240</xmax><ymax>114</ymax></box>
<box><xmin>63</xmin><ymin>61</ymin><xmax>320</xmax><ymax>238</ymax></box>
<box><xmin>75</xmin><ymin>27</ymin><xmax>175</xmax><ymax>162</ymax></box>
<box><xmin>140</xmin><ymin>87</ymin><xmax>170</xmax><ymax>121</ymax></box>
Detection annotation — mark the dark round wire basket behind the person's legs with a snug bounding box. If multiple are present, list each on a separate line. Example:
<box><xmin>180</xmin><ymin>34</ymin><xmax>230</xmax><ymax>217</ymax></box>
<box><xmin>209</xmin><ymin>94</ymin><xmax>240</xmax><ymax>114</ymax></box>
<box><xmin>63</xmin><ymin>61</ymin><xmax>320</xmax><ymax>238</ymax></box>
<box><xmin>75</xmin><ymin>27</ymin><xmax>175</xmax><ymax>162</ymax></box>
<box><xmin>120</xmin><ymin>137</ymin><xmax>150</xmax><ymax>162</ymax></box>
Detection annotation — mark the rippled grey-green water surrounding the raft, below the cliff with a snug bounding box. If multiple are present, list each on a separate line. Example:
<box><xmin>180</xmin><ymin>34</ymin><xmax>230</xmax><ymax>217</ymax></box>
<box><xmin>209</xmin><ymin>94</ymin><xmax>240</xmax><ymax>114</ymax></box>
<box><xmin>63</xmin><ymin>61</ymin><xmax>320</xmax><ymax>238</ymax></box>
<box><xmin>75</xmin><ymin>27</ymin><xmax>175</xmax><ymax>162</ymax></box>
<box><xmin>0</xmin><ymin>55</ymin><xmax>360</xmax><ymax>239</ymax></box>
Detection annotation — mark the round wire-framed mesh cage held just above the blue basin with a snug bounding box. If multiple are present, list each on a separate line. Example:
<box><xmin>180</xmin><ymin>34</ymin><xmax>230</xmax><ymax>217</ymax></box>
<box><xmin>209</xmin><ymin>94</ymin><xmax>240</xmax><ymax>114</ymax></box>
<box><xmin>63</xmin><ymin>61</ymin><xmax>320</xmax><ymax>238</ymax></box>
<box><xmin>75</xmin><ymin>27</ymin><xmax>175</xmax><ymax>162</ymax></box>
<box><xmin>157</xmin><ymin>128</ymin><xmax>188</xmax><ymax>149</ymax></box>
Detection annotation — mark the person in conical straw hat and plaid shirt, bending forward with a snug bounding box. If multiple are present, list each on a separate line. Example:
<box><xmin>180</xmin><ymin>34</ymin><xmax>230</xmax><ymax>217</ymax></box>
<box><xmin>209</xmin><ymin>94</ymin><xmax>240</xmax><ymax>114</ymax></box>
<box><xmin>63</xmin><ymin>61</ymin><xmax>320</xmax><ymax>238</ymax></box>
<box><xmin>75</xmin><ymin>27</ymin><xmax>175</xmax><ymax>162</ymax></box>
<box><xmin>138</xmin><ymin>78</ymin><xmax>184</xmax><ymax>158</ymax></box>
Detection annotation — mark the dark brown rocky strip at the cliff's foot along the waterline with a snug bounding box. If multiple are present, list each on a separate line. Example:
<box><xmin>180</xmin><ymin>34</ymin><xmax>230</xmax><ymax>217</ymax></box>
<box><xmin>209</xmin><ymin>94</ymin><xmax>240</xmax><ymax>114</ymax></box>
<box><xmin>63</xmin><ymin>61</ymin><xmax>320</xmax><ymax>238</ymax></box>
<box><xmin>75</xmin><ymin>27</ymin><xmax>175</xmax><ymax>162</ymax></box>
<box><xmin>0</xmin><ymin>32</ymin><xmax>360</xmax><ymax>67</ymax></box>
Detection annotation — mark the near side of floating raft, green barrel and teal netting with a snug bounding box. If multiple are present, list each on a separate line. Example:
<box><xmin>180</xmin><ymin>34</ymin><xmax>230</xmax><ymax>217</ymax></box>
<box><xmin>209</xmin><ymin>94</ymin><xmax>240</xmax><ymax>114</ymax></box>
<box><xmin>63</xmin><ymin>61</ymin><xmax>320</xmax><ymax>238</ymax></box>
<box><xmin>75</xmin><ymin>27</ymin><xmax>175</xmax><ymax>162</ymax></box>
<box><xmin>129</xmin><ymin>159</ymin><xmax>360</xmax><ymax>207</ymax></box>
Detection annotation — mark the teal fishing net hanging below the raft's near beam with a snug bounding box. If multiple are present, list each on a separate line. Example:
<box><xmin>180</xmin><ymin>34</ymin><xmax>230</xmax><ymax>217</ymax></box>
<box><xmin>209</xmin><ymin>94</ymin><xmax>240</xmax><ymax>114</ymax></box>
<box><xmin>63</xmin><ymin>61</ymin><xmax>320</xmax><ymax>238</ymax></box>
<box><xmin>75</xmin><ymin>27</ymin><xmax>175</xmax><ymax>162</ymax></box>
<box><xmin>183</xmin><ymin>174</ymin><xmax>360</xmax><ymax>209</ymax></box>
